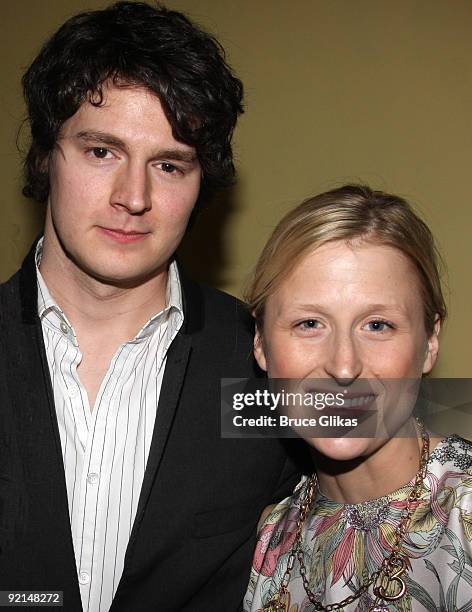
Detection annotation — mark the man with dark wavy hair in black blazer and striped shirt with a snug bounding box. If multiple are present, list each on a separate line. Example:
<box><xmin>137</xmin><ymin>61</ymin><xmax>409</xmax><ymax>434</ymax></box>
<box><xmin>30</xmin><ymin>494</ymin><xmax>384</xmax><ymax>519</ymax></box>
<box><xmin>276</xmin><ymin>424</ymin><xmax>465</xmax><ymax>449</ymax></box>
<box><xmin>0</xmin><ymin>2</ymin><xmax>297</xmax><ymax>612</ymax></box>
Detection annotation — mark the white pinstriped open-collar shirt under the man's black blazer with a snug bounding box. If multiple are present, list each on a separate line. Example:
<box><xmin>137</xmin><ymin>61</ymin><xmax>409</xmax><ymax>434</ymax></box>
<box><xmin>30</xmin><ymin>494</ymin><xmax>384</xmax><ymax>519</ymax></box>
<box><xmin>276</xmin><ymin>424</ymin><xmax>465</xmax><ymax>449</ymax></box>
<box><xmin>36</xmin><ymin>242</ymin><xmax>183</xmax><ymax>612</ymax></box>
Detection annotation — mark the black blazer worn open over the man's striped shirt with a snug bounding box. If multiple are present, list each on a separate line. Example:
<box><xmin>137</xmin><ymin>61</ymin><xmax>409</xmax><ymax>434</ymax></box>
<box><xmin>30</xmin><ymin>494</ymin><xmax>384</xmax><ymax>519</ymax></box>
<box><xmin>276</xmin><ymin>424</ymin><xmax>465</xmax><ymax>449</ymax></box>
<box><xmin>0</xmin><ymin>244</ymin><xmax>299</xmax><ymax>612</ymax></box>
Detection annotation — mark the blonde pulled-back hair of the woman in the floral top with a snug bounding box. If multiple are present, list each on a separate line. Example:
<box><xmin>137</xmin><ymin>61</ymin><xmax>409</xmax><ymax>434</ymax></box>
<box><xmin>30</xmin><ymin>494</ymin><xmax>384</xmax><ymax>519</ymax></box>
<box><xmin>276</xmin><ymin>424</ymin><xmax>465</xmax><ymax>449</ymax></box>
<box><xmin>245</xmin><ymin>185</ymin><xmax>447</xmax><ymax>335</ymax></box>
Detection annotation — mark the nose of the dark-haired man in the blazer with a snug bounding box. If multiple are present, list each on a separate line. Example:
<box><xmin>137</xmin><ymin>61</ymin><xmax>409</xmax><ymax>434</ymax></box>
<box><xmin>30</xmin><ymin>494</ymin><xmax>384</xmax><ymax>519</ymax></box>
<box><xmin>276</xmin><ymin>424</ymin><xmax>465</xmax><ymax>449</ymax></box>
<box><xmin>111</xmin><ymin>161</ymin><xmax>151</xmax><ymax>215</ymax></box>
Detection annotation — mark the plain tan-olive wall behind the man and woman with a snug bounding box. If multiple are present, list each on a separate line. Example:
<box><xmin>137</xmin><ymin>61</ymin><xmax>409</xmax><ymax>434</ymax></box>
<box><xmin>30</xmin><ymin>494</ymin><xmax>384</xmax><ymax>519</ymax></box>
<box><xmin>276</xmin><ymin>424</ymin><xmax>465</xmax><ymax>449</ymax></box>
<box><xmin>0</xmin><ymin>0</ymin><xmax>472</xmax><ymax>377</ymax></box>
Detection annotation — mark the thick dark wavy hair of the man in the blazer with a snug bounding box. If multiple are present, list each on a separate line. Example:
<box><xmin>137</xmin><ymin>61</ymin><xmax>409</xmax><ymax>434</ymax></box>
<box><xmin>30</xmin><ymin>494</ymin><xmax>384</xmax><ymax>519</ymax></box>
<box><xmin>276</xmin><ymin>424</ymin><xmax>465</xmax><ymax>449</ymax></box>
<box><xmin>23</xmin><ymin>2</ymin><xmax>243</xmax><ymax>202</ymax></box>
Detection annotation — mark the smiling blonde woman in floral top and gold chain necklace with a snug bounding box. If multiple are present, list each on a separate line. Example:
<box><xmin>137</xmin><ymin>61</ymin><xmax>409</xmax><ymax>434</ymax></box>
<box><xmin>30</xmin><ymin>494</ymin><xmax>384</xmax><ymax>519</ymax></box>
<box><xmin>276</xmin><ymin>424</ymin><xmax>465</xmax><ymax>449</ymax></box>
<box><xmin>244</xmin><ymin>185</ymin><xmax>472</xmax><ymax>612</ymax></box>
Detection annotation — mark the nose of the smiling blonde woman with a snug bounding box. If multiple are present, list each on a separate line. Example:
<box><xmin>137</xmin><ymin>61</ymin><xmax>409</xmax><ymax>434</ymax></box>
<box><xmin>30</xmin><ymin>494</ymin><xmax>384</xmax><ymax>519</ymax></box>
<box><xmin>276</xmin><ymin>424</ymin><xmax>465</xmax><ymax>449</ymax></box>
<box><xmin>324</xmin><ymin>333</ymin><xmax>363</xmax><ymax>385</ymax></box>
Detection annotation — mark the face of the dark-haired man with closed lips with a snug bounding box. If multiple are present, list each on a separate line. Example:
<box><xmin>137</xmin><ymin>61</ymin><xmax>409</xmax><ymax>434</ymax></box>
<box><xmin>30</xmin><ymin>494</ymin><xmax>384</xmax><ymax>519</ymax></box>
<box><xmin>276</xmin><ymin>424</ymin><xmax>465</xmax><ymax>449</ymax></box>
<box><xmin>44</xmin><ymin>85</ymin><xmax>201</xmax><ymax>286</ymax></box>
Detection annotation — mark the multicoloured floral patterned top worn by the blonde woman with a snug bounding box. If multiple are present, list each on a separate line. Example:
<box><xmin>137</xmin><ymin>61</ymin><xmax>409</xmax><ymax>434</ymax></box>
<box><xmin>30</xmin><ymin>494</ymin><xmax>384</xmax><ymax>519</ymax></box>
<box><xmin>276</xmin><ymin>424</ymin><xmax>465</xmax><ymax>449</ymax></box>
<box><xmin>244</xmin><ymin>436</ymin><xmax>472</xmax><ymax>612</ymax></box>
